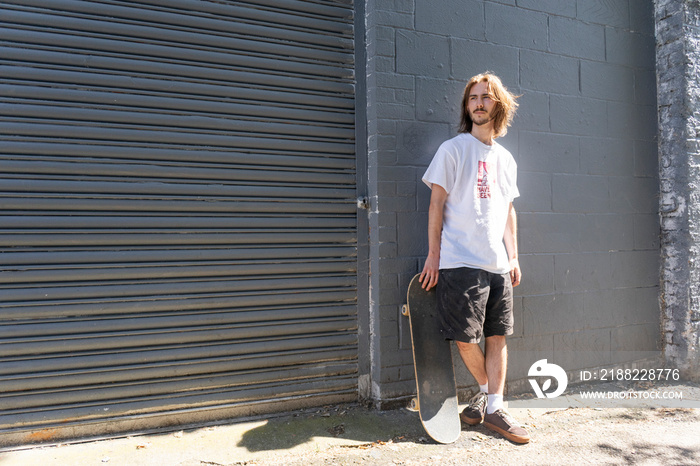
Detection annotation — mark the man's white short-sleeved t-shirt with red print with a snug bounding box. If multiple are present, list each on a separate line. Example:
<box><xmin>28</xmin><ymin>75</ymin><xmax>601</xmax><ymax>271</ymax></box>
<box><xmin>423</xmin><ymin>133</ymin><xmax>520</xmax><ymax>273</ymax></box>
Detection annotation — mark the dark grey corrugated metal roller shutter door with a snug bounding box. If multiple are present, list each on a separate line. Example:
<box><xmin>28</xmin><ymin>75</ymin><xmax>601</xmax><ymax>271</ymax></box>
<box><xmin>0</xmin><ymin>0</ymin><xmax>358</xmax><ymax>443</ymax></box>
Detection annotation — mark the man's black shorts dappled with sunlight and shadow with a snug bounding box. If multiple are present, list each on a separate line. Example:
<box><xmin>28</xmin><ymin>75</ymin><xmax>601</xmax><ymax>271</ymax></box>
<box><xmin>437</xmin><ymin>267</ymin><xmax>513</xmax><ymax>343</ymax></box>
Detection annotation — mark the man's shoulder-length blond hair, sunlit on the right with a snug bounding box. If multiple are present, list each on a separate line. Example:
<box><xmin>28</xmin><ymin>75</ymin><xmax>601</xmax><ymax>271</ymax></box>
<box><xmin>459</xmin><ymin>71</ymin><xmax>518</xmax><ymax>137</ymax></box>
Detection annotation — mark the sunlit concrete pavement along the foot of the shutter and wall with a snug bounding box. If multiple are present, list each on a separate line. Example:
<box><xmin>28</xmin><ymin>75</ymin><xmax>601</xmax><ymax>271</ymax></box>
<box><xmin>0</xmin><ymin>384</ymin><xmax>700</xmax><ymax>466</ymax></box>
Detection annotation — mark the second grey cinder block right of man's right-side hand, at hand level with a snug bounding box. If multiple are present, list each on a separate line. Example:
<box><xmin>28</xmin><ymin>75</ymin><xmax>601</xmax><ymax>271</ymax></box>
<box><xmin>554</xmin><ymin>252</ymin><xmax>612</xmax><ymax>293</ymax></box>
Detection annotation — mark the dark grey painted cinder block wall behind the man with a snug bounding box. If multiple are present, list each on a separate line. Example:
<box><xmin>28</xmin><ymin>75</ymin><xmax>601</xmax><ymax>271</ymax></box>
<box><xmin>363</xmin><ymin>0</ymin><xmax>659</xmax><ymax>403</ymax></box>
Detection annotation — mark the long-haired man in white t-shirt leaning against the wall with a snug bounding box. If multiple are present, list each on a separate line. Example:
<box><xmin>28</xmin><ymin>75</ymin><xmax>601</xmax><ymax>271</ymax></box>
<box><xmin>420</xmin><ymin>73</ymin><xmax>530</xmax><ymax>443</ymax></box>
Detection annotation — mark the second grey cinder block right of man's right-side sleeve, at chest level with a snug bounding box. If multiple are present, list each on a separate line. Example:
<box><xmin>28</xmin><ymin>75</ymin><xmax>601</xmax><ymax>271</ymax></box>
<box><xmin>552</xmin><ymin>174</ymin><xmax>610</xmax><ymax>213</ymax></box>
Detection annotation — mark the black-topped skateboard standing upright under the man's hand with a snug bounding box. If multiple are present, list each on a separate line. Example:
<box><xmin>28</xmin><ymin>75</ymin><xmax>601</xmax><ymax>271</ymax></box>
<box><xmin>401</xmin><ymin>275</ymin><xmax>462</xmax><ymax>443</ymax></box>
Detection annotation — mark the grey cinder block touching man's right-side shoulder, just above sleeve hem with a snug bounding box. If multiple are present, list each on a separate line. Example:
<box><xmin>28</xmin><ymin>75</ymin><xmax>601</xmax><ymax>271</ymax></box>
<box><xmin>518</xmin><ymin>131</ymin><xmax>579</xmax><ymax>173</ymax></box>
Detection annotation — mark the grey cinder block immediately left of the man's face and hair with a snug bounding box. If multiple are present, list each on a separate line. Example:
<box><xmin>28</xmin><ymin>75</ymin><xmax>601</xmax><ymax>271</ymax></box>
<box><xmin>416</xmin><ymin>77</ymin><xmax>464</xmax><ymax>124</ymax></box>
